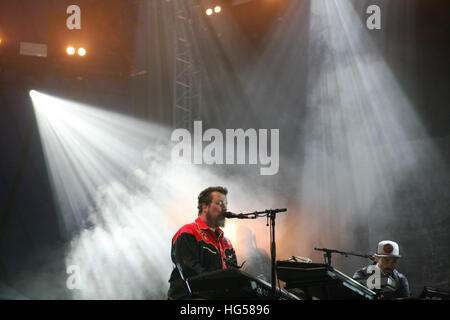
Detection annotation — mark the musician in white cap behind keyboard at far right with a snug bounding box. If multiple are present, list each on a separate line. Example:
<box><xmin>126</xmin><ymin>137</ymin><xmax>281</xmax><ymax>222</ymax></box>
<box><xmin>353</xmin><ymin>240</ymin><xmax>410</xmax><ymax>299</ymax></box>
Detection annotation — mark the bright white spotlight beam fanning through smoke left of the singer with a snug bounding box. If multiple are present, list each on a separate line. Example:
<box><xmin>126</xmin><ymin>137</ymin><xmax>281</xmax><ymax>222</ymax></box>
<box><xmin>29</xmin><ymin>90</ymin><xmax>197</xmax><ymax>299</ymax></box>
